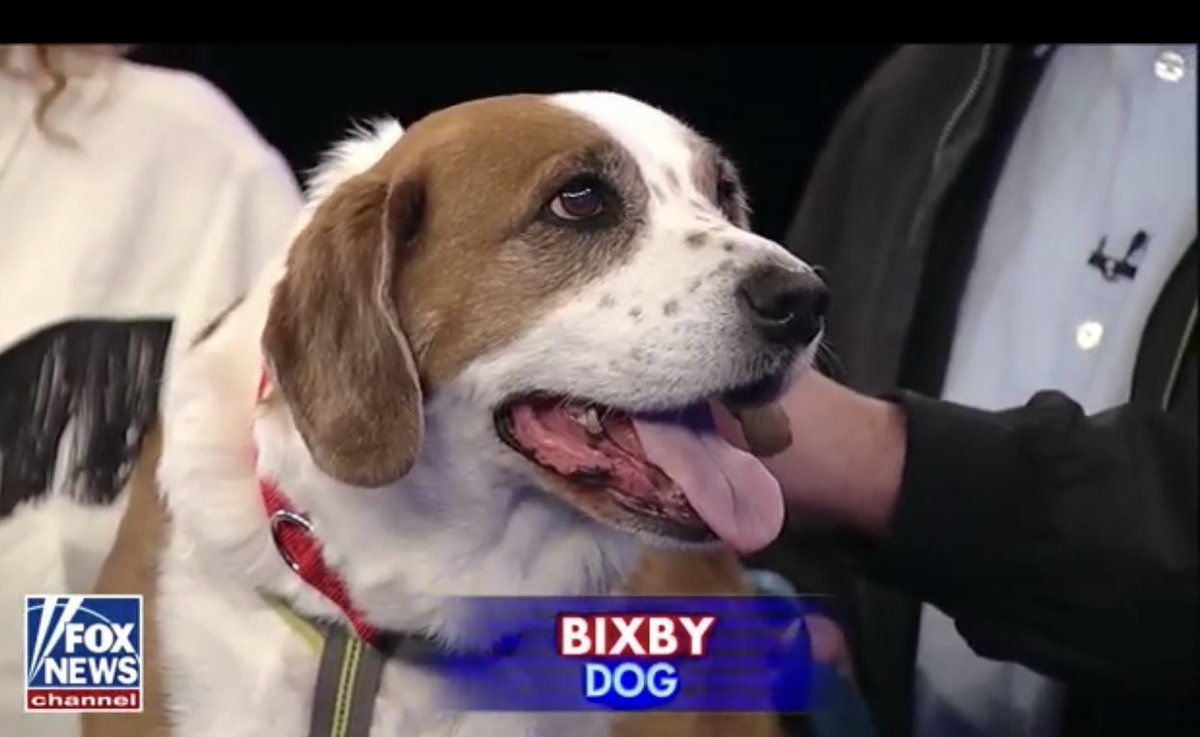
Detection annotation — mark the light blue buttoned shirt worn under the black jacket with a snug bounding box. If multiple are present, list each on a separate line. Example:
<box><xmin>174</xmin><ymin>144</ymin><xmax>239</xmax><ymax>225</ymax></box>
<box><xmin>917</xmin><ymin>46</ymin><xmax>1198</xmax><ymax>737</ymax></box>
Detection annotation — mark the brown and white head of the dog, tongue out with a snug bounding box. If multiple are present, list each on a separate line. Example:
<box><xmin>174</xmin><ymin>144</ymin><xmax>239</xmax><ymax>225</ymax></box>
<box><xmin>263</xmin><ymin>94</ymin><xmax>826</xmax><ymax>547</ymax></box>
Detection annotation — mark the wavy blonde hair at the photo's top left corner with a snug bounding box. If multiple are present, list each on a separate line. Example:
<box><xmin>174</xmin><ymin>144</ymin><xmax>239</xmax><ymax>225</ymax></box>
<box><xmin>0</xmin><ymin>43</ymin><xmax>134</xmax><ymax>140</ymax></box>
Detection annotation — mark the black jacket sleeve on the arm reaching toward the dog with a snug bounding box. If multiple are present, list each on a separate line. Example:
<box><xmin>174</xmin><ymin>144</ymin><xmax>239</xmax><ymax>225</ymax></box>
<box><xmin>868</xmin><ymin>391</ymin><xmax>1198</xmax><ymax>697</ymax></box>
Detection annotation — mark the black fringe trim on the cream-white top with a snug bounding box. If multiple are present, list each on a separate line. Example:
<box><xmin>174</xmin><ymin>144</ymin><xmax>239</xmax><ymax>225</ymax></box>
<box><xmin>0</xmin><ymin>320</ymin><xmax>170</xmax><ymax>519</ymax></box>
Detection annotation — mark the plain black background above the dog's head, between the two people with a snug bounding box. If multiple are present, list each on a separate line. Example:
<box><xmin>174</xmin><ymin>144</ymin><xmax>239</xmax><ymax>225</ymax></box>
<box><xmin>133</xmin><ymin>43</ymin><xmax>893</xmax><ymax>238</ymax></box>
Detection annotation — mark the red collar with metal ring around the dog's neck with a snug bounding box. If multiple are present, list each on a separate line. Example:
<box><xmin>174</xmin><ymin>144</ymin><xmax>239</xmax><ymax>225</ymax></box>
<box><xmin>258</xmin><ymin>369</ymin><xmax>380</xmax><ymax>645</ymax></box>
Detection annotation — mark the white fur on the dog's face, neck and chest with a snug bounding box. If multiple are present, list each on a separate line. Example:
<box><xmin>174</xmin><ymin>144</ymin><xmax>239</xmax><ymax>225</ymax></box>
<box><xmin>158</xmin><ymin>94</ymin><xmax>804</xmax><ymax>737</ymax></box>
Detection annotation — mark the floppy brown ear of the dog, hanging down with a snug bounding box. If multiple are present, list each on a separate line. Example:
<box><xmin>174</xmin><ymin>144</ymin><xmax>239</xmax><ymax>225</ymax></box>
<box><xmin>263</xmin><ymin>172</ymin><xmax>425</xmax><ymax>486</ymax></box>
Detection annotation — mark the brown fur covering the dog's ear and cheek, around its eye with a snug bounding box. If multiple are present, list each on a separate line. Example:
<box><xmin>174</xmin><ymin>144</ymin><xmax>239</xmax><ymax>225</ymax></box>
<box><xmin>264</xmin><ymin>96</ymin><xmax>647</xmax><ymax>486</ymax></box>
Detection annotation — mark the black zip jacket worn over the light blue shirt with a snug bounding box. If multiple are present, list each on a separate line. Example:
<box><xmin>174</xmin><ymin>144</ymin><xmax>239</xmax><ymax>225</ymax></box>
<box><xmin>764</xmin><ymin>46</ymin><xmax>1198</xmax><ymax>737</ymax></box>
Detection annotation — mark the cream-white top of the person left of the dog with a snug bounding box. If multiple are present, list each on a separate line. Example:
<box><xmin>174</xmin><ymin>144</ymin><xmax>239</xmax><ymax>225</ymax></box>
<box><xmin>0</xmin><ymin>48</ymin><xmax>301</xmax><ymax>737</ymax></box>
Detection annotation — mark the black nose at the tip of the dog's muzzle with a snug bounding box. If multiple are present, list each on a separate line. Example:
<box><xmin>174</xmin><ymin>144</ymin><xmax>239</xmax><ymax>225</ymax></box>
<box><xmin>738</xmin><ymin>266</ymin><xmax>829</xmax><ymax>347</ymax></box>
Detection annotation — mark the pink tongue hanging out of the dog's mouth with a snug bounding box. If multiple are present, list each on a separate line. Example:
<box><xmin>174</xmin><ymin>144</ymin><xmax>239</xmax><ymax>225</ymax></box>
<box><xmin>634</xmin><ymin>418</ymin><xmax>784</xmax><ymax>553</ymax></box>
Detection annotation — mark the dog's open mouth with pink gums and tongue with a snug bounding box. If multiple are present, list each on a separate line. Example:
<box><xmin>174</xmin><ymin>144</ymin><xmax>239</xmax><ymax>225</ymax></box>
<box><xmin>496</xmin><ymin>379</ymin><xmax>784</xmax><ymax>552</ymax></box>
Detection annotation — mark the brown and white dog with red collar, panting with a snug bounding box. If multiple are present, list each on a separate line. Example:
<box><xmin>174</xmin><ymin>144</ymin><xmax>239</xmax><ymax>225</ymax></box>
<box><xmin>145</xmin><ymin>92</ymin><xmax>828</xmax><ymax>737</ymax></box>
